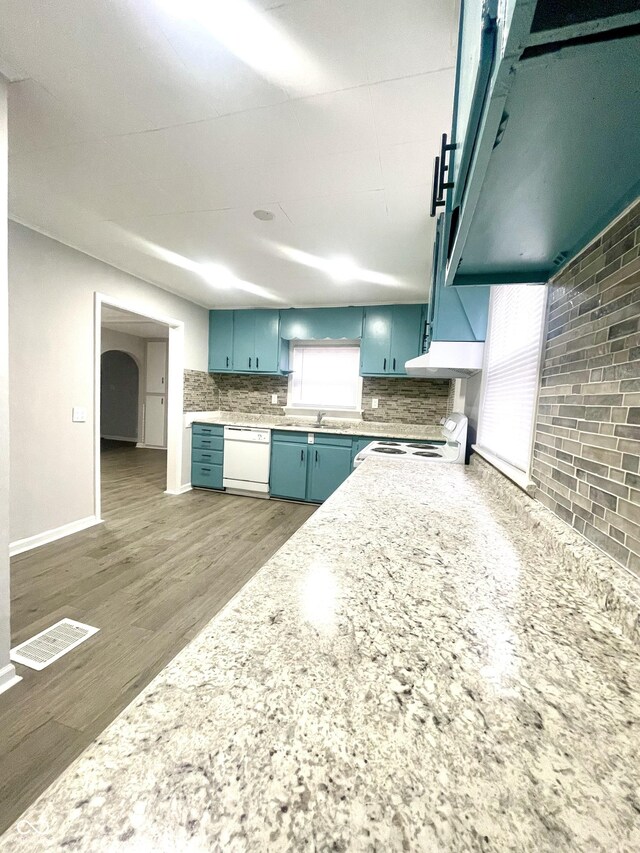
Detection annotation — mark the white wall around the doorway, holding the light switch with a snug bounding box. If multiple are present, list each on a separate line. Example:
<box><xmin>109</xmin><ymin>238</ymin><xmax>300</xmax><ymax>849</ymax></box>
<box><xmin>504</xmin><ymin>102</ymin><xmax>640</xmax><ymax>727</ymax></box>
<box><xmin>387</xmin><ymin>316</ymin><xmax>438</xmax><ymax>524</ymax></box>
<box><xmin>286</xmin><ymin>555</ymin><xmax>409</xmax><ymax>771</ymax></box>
<box><xmin>9</xmin><ymin>222</ymin><xmax>208</xmax><ymax>541</ymax></box>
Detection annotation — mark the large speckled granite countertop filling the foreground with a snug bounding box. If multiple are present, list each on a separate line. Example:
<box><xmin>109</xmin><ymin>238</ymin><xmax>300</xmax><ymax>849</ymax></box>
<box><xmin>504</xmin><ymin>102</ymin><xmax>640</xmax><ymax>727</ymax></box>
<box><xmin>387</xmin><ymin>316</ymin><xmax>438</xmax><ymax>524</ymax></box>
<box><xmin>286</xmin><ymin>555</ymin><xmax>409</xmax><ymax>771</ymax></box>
<box><xmin>0</xmin><ymin>458</ymin><xmax>640</xmax><ymax>853</ymax></box>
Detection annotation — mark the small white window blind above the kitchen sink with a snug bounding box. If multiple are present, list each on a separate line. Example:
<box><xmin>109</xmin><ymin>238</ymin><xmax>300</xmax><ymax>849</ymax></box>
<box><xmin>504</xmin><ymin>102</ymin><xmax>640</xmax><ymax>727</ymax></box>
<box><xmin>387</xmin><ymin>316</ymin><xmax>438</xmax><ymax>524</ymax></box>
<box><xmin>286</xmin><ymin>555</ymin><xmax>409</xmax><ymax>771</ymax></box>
<box><xmin>288</xmin><ymin>344</ymin><xmax>362</xmax><ymax>409</ymax></box>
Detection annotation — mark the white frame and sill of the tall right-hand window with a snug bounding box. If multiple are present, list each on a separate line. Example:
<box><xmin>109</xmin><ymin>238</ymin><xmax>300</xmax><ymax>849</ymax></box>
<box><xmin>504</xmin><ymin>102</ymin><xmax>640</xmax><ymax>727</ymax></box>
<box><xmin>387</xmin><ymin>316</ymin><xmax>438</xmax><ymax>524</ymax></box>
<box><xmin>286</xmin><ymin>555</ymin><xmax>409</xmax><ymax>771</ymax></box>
<box><xmin>472</xmin><ymin>284</ymin><xmax>549</xmax><ymax>494</ymax></box>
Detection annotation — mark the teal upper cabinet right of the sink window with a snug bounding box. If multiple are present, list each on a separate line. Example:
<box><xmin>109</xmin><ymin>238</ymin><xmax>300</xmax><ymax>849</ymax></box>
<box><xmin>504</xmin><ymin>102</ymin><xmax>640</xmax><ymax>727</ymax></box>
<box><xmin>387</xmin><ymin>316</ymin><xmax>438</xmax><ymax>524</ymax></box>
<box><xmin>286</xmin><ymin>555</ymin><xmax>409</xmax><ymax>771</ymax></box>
<box><xmin>360</xmin><ymin>305</ymin><xmax>424</xmax><ymax>376</ymax></box>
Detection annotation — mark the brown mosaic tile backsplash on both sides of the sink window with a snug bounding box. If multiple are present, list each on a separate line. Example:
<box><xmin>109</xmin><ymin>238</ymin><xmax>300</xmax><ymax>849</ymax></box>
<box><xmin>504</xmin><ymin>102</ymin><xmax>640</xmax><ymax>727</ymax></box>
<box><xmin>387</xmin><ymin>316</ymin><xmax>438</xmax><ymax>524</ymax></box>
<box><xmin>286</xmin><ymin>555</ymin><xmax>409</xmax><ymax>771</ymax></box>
<box><xmin>184</xmin><ymin>370</ymin><xmax>452</xmax><ymax>424</ymax></box>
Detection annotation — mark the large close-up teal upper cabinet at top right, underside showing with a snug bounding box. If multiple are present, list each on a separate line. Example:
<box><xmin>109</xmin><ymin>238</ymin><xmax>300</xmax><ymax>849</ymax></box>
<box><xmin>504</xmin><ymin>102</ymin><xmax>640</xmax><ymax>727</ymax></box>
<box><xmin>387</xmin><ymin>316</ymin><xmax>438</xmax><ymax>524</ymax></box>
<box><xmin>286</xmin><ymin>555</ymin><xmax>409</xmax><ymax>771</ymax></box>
<box><xmin>433</xmin><ymin>0</ymin><xmax>640</xmax><ymax>287</ymax></box>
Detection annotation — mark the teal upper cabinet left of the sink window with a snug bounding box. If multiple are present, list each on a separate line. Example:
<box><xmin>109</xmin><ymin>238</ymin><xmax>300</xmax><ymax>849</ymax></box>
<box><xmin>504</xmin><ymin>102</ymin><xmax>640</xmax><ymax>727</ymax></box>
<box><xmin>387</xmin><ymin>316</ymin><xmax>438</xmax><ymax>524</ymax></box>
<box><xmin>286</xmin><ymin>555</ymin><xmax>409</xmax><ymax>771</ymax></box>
<box><xmin>209</xmin><ymin>309</ymin><xmax>288</xmax><ymax>373</ymax></box>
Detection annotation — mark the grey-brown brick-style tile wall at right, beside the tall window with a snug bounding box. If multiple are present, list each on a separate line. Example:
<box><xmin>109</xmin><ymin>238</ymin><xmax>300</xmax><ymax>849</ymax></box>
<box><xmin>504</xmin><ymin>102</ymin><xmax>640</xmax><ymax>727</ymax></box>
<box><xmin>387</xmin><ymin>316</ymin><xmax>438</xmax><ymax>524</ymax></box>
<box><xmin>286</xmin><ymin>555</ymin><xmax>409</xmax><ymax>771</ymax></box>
<box><xmin>532</xmin><ymin>196</ymin><xmax>640</xmax><ymax>574</ymax></box>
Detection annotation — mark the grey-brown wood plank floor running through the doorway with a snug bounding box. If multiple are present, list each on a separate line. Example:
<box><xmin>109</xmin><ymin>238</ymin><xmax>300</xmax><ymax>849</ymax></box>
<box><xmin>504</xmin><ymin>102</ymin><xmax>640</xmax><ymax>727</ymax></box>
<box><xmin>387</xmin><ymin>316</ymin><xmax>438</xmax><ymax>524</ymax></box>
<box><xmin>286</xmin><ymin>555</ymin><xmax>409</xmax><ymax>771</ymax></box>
<box><xmin>0</xmin><ymin>446</ymin><xmax>314</xmax><ymax>832</ymax></box>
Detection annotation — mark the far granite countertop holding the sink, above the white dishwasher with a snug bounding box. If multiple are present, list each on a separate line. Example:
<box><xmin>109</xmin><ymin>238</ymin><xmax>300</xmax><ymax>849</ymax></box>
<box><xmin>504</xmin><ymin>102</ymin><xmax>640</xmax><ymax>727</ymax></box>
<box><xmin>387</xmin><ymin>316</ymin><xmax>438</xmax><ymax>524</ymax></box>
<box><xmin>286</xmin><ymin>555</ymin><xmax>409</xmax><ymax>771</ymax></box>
<box><xmin>193</xmin><ymin>412</ymin><xmax>442</xmax><ymax>441</ymax></box>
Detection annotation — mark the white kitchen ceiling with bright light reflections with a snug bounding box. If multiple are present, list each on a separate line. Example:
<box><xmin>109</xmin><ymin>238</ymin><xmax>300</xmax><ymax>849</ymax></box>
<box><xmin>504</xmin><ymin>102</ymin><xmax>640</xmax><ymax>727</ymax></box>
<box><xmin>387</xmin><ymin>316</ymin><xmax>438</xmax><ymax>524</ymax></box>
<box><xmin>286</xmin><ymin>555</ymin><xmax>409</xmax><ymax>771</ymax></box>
<box><xmin>0</xmin><ymin>0</ymin><xmax>457</xmax><ymax>307</ymax></box>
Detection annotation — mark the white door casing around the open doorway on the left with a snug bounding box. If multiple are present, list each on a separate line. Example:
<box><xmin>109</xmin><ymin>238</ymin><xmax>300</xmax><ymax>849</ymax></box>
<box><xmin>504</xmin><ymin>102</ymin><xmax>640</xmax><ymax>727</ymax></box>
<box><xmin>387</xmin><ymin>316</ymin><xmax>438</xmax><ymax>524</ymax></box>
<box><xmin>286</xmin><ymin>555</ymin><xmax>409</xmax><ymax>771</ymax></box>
<box><xmin>93</xmin><ymin>291</ymin><xmax>184</xmax><ymax>517</ymax></box>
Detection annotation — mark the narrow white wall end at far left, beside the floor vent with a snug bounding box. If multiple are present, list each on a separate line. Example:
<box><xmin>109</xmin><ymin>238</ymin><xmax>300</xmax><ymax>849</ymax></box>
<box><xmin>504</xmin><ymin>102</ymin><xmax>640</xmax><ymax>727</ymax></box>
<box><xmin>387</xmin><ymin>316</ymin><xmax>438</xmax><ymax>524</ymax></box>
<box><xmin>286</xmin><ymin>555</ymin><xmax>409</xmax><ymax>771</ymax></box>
<box><xmin>0</xmin><ymin>75</ymin><xmax>15</xmax><ymax>691</ymax></box>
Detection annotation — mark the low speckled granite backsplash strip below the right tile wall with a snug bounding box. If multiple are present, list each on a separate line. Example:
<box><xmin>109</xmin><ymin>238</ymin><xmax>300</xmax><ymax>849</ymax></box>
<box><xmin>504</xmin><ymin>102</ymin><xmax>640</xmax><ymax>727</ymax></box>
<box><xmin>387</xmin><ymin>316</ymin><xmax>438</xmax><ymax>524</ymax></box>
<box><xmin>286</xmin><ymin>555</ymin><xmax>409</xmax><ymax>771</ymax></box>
<box><xmin>469</xmin><ymin>453</ymin><xmax>640</xmax><ymax>646</ymax></box>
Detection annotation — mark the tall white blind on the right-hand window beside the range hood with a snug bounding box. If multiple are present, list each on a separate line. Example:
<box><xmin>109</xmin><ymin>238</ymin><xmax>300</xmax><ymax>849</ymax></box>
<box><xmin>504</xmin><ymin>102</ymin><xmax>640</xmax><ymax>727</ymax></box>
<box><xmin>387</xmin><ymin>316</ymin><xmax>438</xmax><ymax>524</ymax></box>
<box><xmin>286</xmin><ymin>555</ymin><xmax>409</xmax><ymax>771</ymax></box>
<box><xmin>478</xmin><ymin>284</ymin><xmax>547</xmax><ymax>473</ymax></box>
